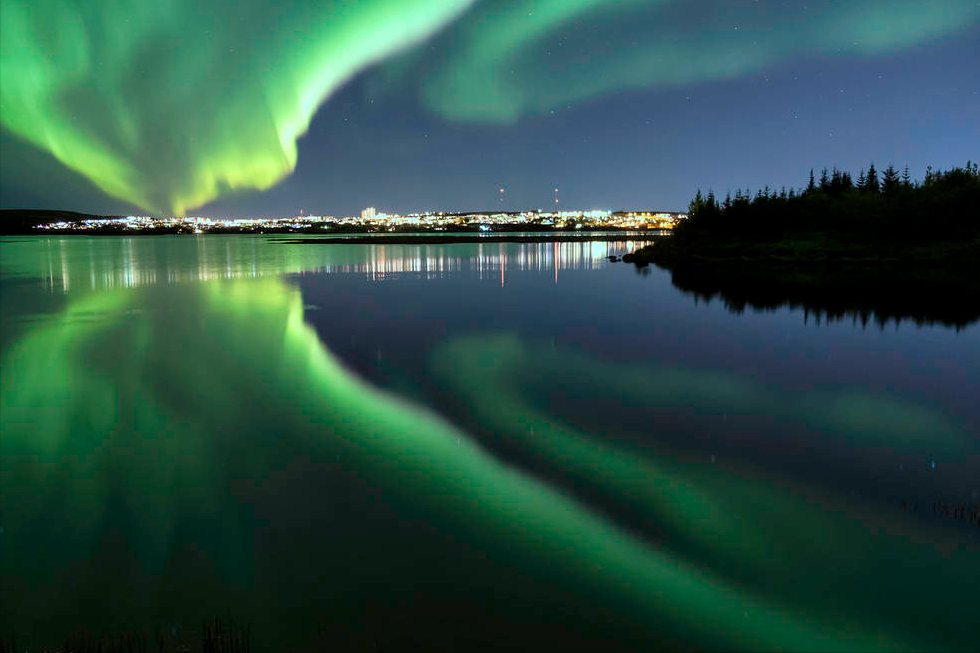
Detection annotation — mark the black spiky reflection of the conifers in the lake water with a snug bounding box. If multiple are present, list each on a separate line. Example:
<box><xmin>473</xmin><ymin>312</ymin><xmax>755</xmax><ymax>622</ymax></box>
<box><xmin>652</xmin><ymin>263</ymin><xmax>980</xmax><ymax>329</ymax></box>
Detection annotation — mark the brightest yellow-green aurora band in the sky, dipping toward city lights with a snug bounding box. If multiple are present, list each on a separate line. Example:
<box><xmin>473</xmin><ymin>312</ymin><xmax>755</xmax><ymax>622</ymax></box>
<box><xmin>0</xmin><ymin>0</ymin><xmax>472</xmax><ymax>214</ymax></box>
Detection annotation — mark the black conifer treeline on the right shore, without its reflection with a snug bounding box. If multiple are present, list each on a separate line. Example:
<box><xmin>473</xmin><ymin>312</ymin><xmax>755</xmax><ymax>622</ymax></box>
<box><xmin>674</xmin><ymin>161</ymin><xmax>980</xmax><ymax>242</ymax></box>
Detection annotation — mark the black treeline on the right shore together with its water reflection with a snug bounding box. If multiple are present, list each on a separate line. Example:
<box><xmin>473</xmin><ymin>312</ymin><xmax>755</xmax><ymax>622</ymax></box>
<box><xmin>622</xmin><ymin>161</ymin><xmax>980</xmax><ymax>328</ymax></box>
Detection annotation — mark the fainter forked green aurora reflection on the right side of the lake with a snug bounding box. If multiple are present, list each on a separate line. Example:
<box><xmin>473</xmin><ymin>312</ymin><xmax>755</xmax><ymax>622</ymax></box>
<box><xmin>432</xmin><ymin>336</ymin><xmax>980</xmax><ymax>648</ymax></box>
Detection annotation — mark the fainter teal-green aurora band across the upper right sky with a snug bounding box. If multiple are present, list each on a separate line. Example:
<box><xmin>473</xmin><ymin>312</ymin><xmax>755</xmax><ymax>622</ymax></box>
<box><xmin>390</xmin><ymin>0</ymin><xmax>980</xmax><ymax>122</ymax></box>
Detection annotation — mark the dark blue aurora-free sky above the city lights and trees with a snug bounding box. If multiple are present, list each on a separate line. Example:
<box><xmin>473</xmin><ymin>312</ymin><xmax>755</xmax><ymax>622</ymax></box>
<box><xmin>0</xmin><ymin>3</ymin><xmax>980</xmax><ymax>216</ymax></box>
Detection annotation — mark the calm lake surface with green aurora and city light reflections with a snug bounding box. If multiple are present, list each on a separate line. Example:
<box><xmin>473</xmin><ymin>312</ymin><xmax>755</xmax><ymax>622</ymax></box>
<box><xmin>0</xmin><ymin>236</ymin><xmax>980</xmax><ymax>651</ymax></box>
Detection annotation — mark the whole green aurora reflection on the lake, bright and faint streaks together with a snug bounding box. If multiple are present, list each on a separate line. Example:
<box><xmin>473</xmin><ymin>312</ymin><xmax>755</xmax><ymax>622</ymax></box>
<box><xmin>0</xmin><ymin>280</ymin><xmax>978</xmax><ymax>650</ymax></box>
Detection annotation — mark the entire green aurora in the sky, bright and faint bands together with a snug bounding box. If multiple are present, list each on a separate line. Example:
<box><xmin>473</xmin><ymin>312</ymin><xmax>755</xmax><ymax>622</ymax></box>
<box><xmin>0</xmin><ymin>0</ymin><xmax>980</xmax><ymax>214</ymax></box>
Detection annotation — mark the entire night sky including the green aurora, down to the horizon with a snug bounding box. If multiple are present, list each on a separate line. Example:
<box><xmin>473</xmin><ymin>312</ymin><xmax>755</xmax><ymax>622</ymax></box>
<box><xmin>0</xmin><ymin>0</ymin><xmax>980</xmax><ymax>217</ymax></box>
